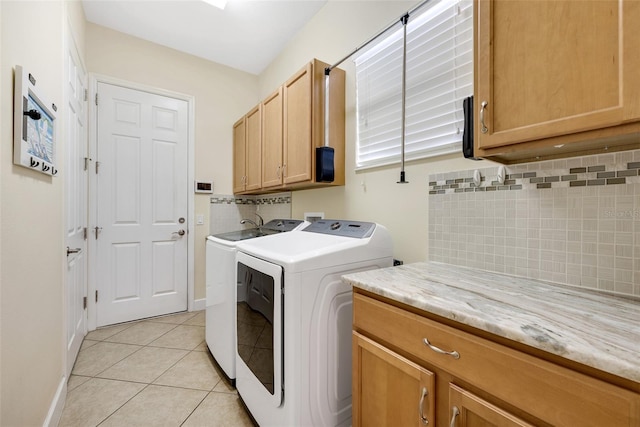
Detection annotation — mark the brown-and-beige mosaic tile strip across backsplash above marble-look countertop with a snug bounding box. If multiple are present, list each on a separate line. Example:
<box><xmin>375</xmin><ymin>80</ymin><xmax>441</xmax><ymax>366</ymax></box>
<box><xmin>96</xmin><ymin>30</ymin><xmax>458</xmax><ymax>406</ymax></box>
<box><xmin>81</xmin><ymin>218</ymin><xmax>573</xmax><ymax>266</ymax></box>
<box><xmin>429</xmin><ymin>162</ymin><xmax>640</xmax><ymax>195</ymax></box>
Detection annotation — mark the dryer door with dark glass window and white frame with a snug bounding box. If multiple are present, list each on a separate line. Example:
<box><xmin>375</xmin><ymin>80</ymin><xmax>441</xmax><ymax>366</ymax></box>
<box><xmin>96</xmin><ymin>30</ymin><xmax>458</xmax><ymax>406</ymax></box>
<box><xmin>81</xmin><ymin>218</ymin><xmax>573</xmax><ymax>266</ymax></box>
<box><xmin>236</xmin><ymin>252</ymin><xmax>284</xmax><ymax>413</ymax></box>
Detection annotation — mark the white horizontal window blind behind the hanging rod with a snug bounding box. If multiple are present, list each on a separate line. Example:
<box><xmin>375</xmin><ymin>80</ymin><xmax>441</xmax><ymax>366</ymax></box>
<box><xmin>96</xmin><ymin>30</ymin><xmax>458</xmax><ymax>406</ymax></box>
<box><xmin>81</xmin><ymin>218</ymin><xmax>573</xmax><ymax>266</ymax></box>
<box><xmin>355</xmin><ymin>0</ymin><xmax>473</xmax><ymax>169</ymax></box>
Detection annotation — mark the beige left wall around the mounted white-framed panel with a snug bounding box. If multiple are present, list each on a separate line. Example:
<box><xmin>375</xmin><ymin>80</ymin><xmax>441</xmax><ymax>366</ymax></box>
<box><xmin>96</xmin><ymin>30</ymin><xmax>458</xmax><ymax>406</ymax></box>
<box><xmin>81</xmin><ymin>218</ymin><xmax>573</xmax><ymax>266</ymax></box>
<box><xmin>0</xmin><ymin>1</ymin><xmax>84</xmax><ymax>426</ymax></box>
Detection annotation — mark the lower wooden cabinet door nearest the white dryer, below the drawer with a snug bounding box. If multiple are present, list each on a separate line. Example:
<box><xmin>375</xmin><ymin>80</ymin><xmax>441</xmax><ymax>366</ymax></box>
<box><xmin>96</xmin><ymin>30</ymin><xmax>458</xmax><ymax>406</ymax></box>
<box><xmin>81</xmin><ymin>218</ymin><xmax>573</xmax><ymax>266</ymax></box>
<box><xmin>352</xmin><ymin>332</ymin><xmax>435</xmax><ymax>427</ymax></box>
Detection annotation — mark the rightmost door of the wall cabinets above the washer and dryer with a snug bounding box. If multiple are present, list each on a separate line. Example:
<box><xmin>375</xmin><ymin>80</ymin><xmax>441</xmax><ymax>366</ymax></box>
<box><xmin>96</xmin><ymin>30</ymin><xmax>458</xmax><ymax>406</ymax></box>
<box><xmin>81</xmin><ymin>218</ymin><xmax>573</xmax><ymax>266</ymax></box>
<box><xmin>283</xmin><ymin>63</ymin><xmax>313</xmax><ymax>184</ymax></box>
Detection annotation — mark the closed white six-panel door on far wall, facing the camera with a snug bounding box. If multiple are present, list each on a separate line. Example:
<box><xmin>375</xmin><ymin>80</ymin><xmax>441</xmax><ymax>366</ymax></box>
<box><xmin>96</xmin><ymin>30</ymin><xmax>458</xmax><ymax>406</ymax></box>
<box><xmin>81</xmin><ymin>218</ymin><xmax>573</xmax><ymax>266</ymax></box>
<box><xmin>91</xmin><ymin>83</ymin><xmax>188</xmax><ymax>326</ymax></box>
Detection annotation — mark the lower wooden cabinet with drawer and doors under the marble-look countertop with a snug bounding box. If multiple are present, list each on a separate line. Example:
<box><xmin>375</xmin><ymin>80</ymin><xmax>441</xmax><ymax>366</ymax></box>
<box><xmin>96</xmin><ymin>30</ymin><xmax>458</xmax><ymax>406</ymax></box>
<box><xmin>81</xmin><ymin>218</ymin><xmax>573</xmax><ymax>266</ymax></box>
<box><xmin>352</xmin><ymin>288</ymin><xmax>640</xmax><ymax>427</ymax></box>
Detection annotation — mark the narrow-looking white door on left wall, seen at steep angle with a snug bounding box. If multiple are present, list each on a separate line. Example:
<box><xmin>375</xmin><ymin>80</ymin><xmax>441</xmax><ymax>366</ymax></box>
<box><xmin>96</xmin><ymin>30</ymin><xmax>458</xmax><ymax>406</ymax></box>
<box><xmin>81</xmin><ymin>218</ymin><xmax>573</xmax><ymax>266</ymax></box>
<box><xmin>64</xmin><ymin>30</ymin><xmax>87</xmax><ymax>373</ymax></box>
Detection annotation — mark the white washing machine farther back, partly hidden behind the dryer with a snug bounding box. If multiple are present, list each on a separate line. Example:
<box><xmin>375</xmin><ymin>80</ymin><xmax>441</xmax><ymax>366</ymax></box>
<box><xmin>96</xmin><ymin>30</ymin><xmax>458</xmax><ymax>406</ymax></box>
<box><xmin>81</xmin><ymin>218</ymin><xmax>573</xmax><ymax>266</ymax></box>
<box><xmin>205</xmin><ymin>219</ymin><xmax>309</xmax><ymax>385</ymax></box>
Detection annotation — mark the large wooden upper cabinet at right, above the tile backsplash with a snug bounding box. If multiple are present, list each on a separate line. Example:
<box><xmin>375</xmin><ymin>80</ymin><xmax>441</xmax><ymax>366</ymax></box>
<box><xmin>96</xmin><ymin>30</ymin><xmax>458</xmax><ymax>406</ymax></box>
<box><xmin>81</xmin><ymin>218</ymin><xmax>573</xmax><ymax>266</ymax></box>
<box><xmin>474</xmin><ymin>0</ymin><xmax>640</xmax><ymax>163</ymax></box>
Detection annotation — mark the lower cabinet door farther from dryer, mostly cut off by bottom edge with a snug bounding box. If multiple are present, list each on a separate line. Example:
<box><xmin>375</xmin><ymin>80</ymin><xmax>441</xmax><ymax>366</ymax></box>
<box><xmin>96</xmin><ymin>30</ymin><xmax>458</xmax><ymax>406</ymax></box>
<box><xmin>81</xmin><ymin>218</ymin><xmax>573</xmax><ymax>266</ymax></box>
<box><xmin>449</xmin><ymin>384</ymin><xmax>533</xmax><ymax>427</ymax></box>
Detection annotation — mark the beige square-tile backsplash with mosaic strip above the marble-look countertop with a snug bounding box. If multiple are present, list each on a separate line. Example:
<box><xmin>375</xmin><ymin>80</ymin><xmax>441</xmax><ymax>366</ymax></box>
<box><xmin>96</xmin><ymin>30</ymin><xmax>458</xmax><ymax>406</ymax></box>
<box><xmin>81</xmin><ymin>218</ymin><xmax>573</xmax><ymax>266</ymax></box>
<box><xmin>429</xmin><ymin>150</ymin><xmax>640</xmax><ymax>296</ymax></box>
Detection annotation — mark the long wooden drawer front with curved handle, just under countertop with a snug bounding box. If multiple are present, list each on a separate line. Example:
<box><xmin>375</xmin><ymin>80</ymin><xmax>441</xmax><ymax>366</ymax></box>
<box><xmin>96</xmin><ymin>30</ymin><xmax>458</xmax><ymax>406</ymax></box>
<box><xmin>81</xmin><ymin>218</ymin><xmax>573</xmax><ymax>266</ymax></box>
<box><xmin>353</xmin><ymin>293</ymin><xmax>640</xmax><ymax>427</ymax></box>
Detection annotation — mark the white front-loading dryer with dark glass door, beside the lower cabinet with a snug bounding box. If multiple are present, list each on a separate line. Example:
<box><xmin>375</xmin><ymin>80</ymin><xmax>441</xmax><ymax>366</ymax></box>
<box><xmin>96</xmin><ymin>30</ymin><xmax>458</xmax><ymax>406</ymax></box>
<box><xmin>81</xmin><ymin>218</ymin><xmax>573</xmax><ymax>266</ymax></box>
<box><xmin>236</xmin><ymin>220</ymin><xmax>393</xmax><ymax>427</ymax></box>
